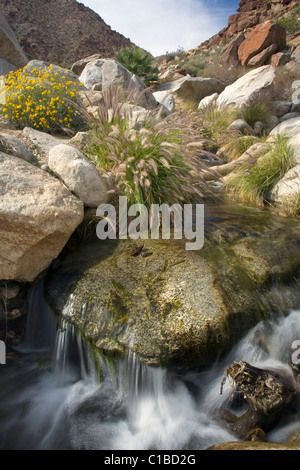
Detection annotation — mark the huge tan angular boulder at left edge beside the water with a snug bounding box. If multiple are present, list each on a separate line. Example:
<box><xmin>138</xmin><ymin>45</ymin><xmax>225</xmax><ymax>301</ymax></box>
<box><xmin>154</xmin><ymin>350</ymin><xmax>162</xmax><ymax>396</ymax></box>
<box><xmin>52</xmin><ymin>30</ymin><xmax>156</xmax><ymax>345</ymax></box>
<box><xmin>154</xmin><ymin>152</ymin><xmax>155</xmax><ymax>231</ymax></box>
<box><xmin>0</xmin><ymin>153</ymin><xmax>83</xmax><ymax>282</ymax></box>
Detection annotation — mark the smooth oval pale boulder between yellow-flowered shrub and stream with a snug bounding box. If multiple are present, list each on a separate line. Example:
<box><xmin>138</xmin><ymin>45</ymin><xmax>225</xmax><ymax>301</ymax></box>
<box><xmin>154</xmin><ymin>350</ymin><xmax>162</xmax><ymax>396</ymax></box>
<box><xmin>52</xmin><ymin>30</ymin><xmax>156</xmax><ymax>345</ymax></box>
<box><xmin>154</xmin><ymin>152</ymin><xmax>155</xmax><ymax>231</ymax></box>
<box><xmin>48</xmin><ymin>144</ymin><xmax>108</xmax><ymax>207</ymax></box>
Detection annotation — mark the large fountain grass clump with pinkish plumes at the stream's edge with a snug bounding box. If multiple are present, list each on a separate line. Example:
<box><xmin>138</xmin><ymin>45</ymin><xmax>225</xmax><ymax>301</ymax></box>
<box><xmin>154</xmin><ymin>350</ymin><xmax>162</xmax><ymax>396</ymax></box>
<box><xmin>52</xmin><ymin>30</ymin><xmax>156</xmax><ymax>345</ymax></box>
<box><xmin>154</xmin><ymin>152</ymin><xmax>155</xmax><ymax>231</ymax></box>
<box><xmin>88</xmin><ymin>86</ymin><xmax>213</xmax><ymax>207</ymax></box>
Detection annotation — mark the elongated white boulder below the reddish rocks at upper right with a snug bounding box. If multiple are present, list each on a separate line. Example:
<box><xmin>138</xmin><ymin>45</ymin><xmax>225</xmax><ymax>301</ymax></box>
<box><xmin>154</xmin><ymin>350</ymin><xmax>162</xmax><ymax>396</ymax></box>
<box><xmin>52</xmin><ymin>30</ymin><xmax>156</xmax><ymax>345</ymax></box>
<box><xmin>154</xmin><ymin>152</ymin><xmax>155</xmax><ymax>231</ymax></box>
<box><xmin>217</xmin><ymin>65</ymin><xmax>275</xmax><ymax>106</ymax></box>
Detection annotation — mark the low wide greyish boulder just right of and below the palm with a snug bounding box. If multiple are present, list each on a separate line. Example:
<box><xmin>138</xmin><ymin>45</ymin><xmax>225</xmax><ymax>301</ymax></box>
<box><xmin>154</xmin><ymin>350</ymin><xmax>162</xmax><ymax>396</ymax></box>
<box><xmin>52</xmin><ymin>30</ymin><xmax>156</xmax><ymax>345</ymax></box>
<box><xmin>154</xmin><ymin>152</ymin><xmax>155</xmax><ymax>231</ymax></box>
<box><xmin>158</xmin><ymin>76</ymin><xmax>225</xmax><ymax>104</ymax></box>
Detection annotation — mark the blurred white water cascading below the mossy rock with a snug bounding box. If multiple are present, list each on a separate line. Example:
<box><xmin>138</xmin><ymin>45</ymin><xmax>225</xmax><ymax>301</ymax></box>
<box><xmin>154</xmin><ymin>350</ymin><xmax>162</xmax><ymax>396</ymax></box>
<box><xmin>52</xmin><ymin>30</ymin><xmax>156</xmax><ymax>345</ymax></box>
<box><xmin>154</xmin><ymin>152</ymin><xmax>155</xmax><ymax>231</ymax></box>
<box><xmin>0</xmin><ymin>284</ymin><xmax>300</xmax><ymax>450</ymax></box>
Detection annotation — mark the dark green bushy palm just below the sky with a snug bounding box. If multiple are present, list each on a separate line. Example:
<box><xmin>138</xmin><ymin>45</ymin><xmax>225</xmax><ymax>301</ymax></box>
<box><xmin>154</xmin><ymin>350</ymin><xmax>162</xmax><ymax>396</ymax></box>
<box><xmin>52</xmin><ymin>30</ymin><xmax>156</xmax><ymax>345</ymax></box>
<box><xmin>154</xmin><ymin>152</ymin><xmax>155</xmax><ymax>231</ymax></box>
<box><xmin>115</xmin><ymin>47</ymin><xmax>158</xmax><ymax>85</ymax></box>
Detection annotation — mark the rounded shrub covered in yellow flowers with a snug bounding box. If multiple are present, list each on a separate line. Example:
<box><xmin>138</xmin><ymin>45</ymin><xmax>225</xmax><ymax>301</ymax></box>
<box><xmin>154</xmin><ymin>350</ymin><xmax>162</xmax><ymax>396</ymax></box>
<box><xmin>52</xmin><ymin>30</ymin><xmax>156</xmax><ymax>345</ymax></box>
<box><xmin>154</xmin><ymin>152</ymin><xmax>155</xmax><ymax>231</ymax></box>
<box><xmin>2</xmin><ymin>65</ymin><xmax>83</xmax><ymax>132</ymax></box>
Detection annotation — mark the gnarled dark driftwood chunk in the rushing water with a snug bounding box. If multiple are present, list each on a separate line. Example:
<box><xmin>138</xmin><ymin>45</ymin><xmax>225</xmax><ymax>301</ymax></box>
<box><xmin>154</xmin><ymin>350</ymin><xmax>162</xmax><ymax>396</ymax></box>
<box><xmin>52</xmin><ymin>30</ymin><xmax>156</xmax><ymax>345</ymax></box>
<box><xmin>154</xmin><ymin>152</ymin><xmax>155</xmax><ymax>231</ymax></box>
<box><xmin>218</xmin><ymin>361</ymin><xmax>298</xmax><ymax>441</ymax></box>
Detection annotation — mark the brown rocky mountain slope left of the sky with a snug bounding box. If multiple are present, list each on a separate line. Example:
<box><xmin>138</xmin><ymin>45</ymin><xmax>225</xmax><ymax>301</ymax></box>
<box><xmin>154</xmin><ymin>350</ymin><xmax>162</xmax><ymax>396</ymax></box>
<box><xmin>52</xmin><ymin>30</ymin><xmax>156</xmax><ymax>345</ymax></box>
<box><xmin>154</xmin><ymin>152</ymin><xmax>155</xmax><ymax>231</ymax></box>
<box><xmin>0</xmin><ymin>0</ymin><xmax>134</xmax><ymax>66</ymax></box>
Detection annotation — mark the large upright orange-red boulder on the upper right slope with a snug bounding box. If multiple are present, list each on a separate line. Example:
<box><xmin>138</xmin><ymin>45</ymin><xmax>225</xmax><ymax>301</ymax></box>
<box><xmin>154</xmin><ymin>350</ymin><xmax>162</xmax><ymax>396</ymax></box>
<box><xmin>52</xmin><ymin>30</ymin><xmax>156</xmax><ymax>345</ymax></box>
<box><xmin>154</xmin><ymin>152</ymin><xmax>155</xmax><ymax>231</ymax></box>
<box><xmin>238</xmin><ymin>20</ymin><xmax>286</xmax><ymax>65</ymax></box>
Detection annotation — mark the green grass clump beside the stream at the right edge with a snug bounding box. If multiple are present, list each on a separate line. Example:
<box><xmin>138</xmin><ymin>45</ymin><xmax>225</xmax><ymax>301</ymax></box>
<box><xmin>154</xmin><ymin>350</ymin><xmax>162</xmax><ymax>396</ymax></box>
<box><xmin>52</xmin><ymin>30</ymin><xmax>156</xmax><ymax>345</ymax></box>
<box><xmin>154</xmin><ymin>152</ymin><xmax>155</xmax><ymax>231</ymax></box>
<box><xmin>227</xmin><ymin>136</ymin><xmax>295</xmax><ymax>206</ymax></box>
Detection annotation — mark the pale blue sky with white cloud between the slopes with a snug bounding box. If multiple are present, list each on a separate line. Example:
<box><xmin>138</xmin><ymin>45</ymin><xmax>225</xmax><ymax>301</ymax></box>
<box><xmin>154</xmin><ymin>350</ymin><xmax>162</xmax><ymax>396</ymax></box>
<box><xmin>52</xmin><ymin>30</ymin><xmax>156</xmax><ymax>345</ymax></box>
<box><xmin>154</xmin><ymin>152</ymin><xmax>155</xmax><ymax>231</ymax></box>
<box><xmin>79</xmin><ymin>0</ymin><xmax>239</xmax><ymax>57</ymax></box>
